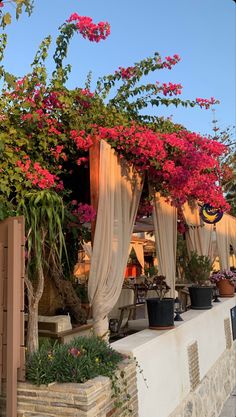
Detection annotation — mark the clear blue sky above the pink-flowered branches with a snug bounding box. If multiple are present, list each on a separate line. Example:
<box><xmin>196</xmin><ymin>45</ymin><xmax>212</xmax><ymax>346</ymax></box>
<box><xmin>2</xmin><ymin>0</ymin><xmax>236</xmax><ymax>134</ymax></box>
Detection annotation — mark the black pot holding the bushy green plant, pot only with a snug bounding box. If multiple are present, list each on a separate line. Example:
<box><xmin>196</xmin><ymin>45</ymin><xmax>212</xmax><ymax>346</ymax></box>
<box><xmin>189</xmin><ymin>287</ymin><xmax>213</xmax><ymax>310</ymax></box>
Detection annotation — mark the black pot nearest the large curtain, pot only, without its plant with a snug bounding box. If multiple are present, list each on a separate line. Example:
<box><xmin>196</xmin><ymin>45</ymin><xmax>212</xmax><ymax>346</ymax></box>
<box><xmin>146</xmin><ymin>298</ymin><xmax>174</xmax><ymax>330</ymax></box>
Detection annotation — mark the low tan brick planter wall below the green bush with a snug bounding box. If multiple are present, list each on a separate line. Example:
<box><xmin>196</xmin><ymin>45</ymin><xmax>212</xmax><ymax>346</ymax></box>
<box><xmin>17</xmin><ymin>360</ymin><xmax>138</xmax><ymax>417</ymax></box>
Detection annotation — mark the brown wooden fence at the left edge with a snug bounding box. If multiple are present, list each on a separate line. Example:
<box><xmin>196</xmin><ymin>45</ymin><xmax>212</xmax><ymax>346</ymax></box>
<box><xmin>0</xmin><ymin>217</ymin><xmax>25</xmax><ymax>417</ymax></box>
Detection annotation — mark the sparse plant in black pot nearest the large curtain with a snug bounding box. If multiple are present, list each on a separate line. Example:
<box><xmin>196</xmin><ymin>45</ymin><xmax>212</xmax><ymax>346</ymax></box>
<box><xmin>146</xmin><ymin>275</ymin><xmax>174</xmax><ymax>330</ymax></box>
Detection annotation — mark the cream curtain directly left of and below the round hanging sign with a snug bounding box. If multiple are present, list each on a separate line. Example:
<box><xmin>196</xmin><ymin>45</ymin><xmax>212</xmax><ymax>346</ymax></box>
<box><xmin>182</xmin><ymin>202</ymin><xmax>215</xmax><ymax>261</ymax></box>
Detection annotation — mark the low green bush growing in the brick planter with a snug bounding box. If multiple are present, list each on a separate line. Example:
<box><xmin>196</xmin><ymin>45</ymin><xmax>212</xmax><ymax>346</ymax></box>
<box><xmin>26</xmin><ymin>336</ymin><xmax>123</xmax><ymax>385</ymax></box>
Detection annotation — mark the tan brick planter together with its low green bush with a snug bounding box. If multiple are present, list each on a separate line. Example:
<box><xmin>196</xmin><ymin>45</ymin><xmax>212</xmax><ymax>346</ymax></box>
<box><xmin>18</xmin><ymin>337</ymin><xmax>137</xmax><ymax>417</ymax></box>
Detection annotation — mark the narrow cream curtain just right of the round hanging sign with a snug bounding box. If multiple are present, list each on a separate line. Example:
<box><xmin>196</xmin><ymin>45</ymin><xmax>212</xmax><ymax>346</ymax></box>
<box><xmin>216</xmin><ymin>214</ymin><xmax>230</xmax><ymax>269</ymax></box>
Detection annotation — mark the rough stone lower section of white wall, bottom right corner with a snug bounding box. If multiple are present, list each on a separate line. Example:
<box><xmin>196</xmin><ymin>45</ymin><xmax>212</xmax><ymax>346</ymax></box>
<box><xmin>169</xmin><ymin>341</ymin><xmax>236</xmax><ymax>417</ymax></box>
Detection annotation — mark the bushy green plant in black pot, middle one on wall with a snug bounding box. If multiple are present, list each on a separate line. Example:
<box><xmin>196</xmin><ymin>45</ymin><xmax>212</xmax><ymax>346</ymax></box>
<box><xmin>184</xmin><ymin>252</ymin><xmax>213</xmax><ymax>310</ymax></box>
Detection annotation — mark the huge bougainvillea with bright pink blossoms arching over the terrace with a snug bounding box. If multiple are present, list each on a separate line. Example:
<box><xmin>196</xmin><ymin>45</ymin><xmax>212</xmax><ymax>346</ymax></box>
<box><xmin>0</xmin><ymin>7</ymin><xmax>232</xmax><ymax>352</ymax></box>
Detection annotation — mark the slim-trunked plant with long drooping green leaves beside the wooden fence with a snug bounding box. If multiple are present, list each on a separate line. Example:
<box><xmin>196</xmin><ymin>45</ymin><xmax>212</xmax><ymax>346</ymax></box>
<box><xmin>17</xmin><ymin>190</ymin><xmax>66</xmax><ymax>352</ymax></box>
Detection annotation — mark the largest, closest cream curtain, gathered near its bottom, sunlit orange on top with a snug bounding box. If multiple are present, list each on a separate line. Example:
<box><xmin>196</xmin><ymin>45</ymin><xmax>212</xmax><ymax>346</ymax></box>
<box><xmin>88</xmin><ymin>141</ymin><xmax>143</xmax><ymax>337</ymax></box>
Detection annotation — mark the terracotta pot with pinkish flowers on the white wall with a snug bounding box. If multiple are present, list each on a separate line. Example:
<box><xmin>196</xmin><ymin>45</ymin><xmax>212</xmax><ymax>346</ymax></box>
<box><xmin>210</xmin><ymin>269</ymin><xmax>236</xmax><ymax>297</ymax></box>
